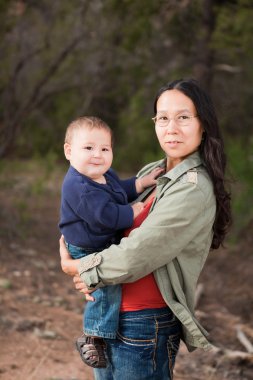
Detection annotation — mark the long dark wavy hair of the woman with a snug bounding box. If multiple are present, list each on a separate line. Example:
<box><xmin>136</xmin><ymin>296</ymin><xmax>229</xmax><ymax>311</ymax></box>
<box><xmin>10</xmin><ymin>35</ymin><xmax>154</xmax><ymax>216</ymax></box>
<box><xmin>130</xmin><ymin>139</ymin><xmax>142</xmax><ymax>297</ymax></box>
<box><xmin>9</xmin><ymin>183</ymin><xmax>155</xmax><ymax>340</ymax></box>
<box><xmin>154</xmin><ymin>79</ymin><xmax>232</xmax><ymax>249</ymax></box>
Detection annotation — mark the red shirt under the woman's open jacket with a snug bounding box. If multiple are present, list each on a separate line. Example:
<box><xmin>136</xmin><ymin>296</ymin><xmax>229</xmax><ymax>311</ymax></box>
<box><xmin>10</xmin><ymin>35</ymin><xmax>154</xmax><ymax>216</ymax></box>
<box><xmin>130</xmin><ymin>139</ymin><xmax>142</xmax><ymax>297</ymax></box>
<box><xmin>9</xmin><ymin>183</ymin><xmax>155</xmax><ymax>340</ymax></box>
<box><xmin>120</xmin><ymin>197</ymin><xmax>167</xmax><ymax>311</ymax></box>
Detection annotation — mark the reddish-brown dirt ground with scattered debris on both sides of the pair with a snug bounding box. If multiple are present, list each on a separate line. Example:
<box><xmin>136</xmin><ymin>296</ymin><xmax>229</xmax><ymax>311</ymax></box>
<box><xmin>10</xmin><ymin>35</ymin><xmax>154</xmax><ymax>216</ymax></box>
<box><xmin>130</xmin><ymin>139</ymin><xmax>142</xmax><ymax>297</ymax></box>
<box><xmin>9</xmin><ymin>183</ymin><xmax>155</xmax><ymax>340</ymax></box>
<box><xmin>0</xmin><ymin>166</ymin><xmax>253</xmax><ymax>380</ymax></box>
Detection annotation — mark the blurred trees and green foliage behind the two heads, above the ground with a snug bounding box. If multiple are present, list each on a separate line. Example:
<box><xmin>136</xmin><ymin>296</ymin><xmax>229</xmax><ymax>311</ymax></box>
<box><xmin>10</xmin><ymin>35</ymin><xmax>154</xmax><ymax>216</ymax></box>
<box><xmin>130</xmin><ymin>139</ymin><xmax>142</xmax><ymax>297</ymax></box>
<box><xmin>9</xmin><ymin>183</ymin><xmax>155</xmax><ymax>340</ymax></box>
<box><xmin>0</xmin><ymin>0</ymin><xmax>253</xmax><ymax>236</ymax></box>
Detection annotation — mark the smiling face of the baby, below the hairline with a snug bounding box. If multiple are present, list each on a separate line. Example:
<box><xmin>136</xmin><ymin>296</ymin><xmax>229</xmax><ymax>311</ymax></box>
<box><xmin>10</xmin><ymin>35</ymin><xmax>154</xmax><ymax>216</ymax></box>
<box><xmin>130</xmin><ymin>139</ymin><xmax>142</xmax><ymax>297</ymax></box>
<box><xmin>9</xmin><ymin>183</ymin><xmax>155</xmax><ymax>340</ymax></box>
<box><xmin>64</xmin><ymin>128</ymin><xmax>113</xmax><ymax>182</ymax></box>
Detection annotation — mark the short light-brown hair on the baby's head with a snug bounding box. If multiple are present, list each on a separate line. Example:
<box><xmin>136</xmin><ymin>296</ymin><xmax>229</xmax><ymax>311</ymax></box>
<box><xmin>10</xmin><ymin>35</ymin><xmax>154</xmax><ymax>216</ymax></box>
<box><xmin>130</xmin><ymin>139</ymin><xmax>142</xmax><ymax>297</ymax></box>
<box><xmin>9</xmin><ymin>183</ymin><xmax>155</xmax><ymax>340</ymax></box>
<box><xmin>65</xmin><ymin>116</ymin><xmax>113</xmax><ymax>144</ymax></box>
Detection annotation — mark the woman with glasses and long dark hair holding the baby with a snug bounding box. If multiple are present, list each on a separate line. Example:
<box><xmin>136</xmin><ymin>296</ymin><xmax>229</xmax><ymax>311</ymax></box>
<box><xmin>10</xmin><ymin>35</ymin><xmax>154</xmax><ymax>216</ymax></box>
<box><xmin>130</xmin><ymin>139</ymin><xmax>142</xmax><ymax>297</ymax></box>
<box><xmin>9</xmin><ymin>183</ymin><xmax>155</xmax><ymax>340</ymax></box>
<box><xmin>60</xmin><ymin>80</ymin><xmax>231</xmax><ymax>380</ymax></box>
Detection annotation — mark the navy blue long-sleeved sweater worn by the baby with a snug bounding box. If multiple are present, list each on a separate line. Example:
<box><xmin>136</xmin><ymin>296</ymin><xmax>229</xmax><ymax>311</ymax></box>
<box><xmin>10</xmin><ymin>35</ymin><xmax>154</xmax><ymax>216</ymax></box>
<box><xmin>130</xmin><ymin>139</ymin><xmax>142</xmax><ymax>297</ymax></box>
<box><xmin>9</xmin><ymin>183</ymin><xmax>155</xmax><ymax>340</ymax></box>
<box><xmin>59</xmin><ymin>166</ymin><xmax>138</xmax><ymax>249</ymax></box>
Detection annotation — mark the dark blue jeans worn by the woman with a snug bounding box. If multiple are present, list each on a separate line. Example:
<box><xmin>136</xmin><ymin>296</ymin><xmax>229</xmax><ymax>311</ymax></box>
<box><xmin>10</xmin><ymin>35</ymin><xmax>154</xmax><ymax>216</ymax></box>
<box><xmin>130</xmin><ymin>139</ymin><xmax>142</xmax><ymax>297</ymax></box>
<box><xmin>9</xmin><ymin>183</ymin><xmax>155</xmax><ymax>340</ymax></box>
<box><xmin>94</xmin><ymin>307</ymin><xmax>181</xmax><ymax>380</ymax></box>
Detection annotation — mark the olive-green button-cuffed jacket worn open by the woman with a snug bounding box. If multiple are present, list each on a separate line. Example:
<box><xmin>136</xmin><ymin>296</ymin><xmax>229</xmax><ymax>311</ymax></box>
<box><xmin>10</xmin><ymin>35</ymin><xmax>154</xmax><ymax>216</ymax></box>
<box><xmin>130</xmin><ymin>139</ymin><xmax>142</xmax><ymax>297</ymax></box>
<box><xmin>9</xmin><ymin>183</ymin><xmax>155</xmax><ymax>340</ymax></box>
<box><xmin>79</xmin><ymin>152</ymin><xmax>216</xmax><ymax>351</ymax></box>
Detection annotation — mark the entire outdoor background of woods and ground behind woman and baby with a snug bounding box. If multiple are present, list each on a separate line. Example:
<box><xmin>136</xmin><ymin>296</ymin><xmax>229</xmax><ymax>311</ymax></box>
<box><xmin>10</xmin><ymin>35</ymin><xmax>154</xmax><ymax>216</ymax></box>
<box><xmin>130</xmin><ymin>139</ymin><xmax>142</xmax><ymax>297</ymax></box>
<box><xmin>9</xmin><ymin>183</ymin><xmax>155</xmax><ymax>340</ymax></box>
<box><xmin>0</xmin><ymin>0</ymin><xmax>253</xmax><ymax>380</ymax></box>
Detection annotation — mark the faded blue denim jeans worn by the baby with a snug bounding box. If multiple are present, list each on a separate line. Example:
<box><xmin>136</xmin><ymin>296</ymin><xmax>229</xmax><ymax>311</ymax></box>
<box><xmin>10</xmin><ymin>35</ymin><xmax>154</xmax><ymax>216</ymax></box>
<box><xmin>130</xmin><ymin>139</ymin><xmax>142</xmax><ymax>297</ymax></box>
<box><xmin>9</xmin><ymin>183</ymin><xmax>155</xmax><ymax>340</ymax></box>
<box><xmin>66</xmin><ymin>243</ymin><xmax>121</xmax><ymax>339</ymax></box>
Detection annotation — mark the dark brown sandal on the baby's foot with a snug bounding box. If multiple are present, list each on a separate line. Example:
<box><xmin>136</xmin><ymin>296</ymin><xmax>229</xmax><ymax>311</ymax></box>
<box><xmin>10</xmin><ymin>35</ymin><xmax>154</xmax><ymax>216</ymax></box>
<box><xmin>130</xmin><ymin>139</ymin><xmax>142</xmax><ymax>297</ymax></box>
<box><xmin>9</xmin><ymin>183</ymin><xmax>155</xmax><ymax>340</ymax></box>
<box><xmin>76</xmin><ymin>335</ymin><xmax>106</xmax><ymax>368</ymax></box>
